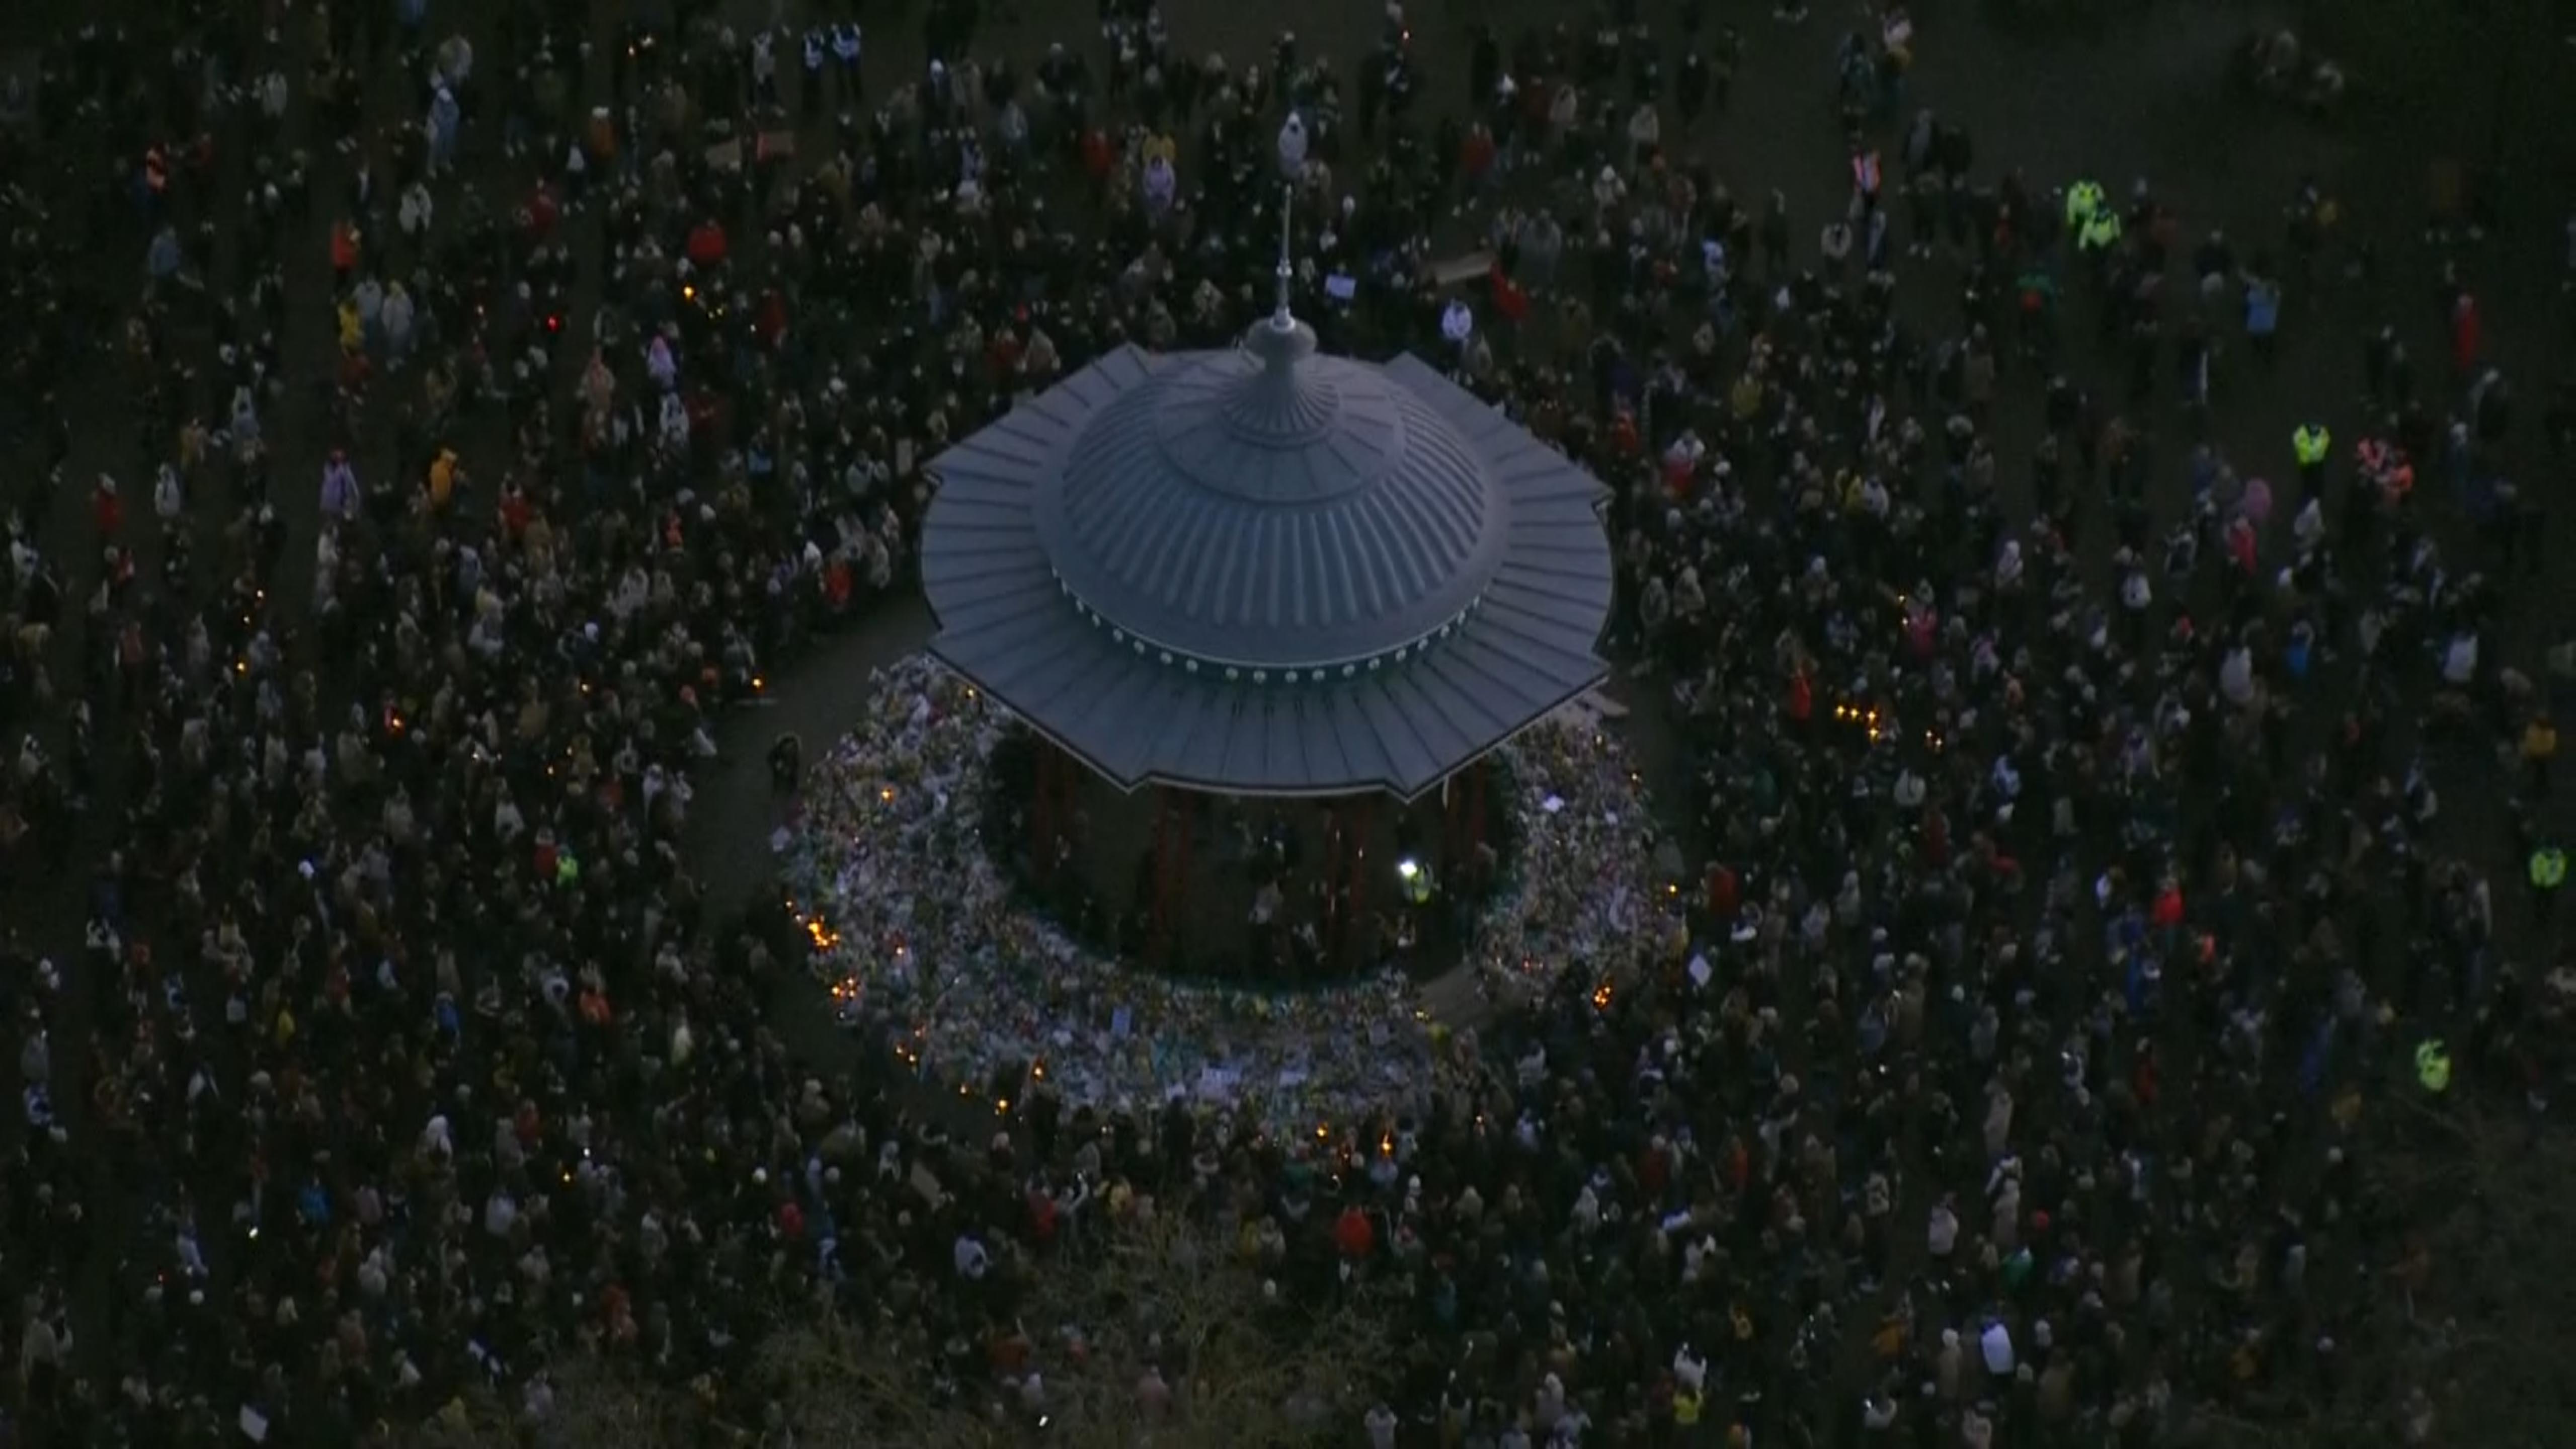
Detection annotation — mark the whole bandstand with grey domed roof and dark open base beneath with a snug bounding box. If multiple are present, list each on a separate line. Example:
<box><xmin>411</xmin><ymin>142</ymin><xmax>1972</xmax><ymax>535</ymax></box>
<box><xmin>922</xmin><ymin>266</ymin><xmax>1613</xmax><ymax>972</ymax></box>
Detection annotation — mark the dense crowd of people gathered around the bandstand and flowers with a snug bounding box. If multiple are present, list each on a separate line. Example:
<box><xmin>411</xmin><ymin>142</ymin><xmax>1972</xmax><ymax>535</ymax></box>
<box><xmin>0</xmin><ymin>0</ymin><xmax>2576</xmax><ymax>1449</ymax></box>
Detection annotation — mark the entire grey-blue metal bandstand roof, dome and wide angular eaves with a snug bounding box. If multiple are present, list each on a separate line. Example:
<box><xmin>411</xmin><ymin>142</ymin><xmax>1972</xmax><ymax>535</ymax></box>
<box><xmin>922</xmin><ymin>314</ymin><xmax>1610</xmax><ymax>796</ymax></box>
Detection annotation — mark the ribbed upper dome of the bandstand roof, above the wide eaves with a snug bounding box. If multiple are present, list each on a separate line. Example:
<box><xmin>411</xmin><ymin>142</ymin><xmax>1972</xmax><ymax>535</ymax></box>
<box><xmin>1035</xmin><ymin>323</ymin><xmax>1509</xmax><ymax>678</ymax></box>
